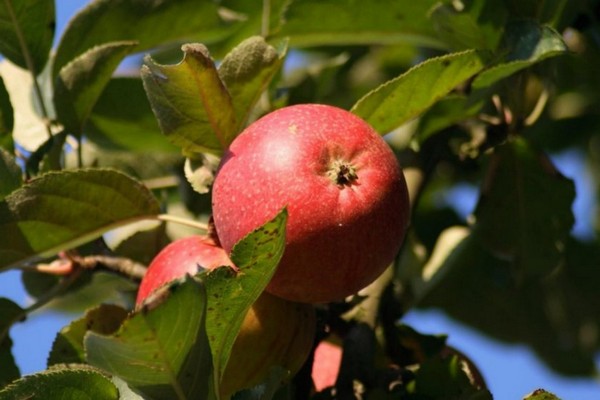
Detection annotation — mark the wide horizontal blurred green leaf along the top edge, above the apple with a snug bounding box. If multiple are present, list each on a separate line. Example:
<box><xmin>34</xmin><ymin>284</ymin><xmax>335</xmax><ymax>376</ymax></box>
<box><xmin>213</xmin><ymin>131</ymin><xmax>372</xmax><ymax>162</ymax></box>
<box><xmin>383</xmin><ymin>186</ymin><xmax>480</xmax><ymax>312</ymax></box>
<box><xmin>275</xmin><ymin>0</ymin><xmax>443</xmax><ymax>48</ymax></box>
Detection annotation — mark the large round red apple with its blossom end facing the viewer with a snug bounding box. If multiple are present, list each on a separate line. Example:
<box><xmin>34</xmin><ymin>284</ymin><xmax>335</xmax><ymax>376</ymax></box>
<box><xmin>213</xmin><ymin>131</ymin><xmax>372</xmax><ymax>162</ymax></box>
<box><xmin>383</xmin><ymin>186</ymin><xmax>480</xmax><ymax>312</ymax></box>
<box><xmin>212</xmin><ymin>104</ymin><xmax>410</xmax><ymax>303</ymax></box>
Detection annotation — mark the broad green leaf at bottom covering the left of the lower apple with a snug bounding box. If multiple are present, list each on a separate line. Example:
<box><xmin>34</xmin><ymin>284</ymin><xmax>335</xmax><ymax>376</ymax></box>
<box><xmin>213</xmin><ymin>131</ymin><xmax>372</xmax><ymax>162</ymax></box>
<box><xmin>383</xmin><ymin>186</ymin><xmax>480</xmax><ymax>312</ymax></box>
<box><xmin>84</xmin><ymin>276</ymin><xmax>212</xmax><ymax>399</ymax></box>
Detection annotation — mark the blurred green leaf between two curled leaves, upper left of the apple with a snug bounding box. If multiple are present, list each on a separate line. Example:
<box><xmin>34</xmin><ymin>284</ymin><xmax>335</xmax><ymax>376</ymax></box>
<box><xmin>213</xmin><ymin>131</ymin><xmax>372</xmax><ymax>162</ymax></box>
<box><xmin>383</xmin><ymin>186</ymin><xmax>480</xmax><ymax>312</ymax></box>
<box><xmin>85</xmin><ymin>77</ymin><xmax>178</xmax><ymax>153</ymax></box>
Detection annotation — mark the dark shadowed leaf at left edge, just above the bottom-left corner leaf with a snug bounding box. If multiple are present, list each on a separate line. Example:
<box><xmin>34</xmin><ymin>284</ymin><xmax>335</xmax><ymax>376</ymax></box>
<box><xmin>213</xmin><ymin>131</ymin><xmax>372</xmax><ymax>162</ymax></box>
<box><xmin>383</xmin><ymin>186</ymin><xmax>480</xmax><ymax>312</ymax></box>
<box><xmin>0</xmin><ymin>297</ymin><xmax>25</xmax><ymax>388</ymax></box>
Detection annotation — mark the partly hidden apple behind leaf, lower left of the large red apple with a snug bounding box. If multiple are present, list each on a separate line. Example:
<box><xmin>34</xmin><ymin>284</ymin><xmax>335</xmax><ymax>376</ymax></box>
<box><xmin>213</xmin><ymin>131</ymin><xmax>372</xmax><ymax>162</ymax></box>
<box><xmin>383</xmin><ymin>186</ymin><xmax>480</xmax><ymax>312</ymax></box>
<box><xmin>136</xmin><ymin>236</ymin><xmax>316</xmax><ymax>399</ymax></box>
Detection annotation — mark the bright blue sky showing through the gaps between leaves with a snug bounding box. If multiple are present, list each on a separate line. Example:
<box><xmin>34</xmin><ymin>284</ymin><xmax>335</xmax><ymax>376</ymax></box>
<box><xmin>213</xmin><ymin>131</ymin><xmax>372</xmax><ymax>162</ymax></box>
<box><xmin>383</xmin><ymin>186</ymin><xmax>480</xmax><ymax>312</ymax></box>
<box><xmin>0</xmin><ymin>0</ymin><xmax>600</xmax><ymax>400</ymax></box>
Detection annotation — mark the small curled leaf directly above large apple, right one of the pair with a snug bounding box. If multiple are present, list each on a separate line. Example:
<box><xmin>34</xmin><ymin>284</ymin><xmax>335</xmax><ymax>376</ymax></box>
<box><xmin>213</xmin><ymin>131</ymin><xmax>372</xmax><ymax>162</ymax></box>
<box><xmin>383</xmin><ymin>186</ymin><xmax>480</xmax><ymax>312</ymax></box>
<box><xmin>219</xmin><ymin>36</ymin><xmax>285</xmax><ymax>134</ymax></box>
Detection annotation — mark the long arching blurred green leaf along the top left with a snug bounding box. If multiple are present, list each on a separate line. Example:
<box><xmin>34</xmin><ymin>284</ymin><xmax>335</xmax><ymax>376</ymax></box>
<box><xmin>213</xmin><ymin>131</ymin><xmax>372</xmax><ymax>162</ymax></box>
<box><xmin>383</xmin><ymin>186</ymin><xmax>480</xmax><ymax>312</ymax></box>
<box><xmin>52</xmin><ymin>0</ymin><xmax>236</xmax><ymax>76</ymax></box>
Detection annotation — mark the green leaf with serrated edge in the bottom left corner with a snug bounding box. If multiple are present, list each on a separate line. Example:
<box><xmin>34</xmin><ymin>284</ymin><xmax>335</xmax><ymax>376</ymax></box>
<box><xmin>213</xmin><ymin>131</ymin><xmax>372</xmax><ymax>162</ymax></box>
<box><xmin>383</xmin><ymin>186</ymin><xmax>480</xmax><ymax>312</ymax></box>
<box><xmin>0</xmin><ymin>365</ymin><xmax>121</xmax><ymax>400</ymax></box>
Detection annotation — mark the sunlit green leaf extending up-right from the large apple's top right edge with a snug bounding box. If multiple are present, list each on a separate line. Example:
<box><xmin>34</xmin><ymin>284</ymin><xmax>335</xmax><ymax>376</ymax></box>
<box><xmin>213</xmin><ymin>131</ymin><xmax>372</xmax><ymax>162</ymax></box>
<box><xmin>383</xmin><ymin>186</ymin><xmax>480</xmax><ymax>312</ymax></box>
<box><xmin>352</xmin><ymin>50</ymin><xmax>486</xmax><ymax>135</ymax></box>
